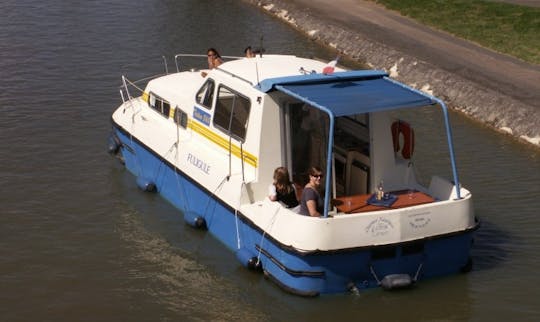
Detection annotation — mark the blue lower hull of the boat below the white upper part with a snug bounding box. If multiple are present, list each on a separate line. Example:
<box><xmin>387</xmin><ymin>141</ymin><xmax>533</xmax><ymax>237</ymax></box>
<box><xmin>113</xmin><ymin>125</ymin><xmax>478</xmax><ymax>296</ymax></box>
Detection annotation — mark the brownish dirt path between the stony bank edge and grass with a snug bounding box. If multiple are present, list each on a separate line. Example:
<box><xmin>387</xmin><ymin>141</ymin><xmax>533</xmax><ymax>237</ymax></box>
<box><xmin>292</xmin><ymin>0</ymin><xmax>540</xmax><ymax>108</ymax></box>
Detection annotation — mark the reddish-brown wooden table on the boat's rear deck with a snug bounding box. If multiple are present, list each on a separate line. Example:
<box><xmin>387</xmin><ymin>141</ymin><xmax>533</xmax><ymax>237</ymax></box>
<box><xmin>332</xmin><ymin>190</ymin><xmax>435</xmax><ymax>214</ymax></box>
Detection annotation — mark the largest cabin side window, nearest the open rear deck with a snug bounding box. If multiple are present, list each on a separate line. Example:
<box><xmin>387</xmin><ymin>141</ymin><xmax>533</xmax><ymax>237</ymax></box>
<box><xmin>214</xmin><ymin>86</ymin><xmax>251</xmax><ymax>141</ymax></box>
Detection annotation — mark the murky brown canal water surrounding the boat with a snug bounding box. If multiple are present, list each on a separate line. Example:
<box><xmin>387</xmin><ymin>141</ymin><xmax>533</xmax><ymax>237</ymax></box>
<box><xmin>0</xmin><ymin>0</ymin><xmax>540</xmax><ymax>321</ymax></box>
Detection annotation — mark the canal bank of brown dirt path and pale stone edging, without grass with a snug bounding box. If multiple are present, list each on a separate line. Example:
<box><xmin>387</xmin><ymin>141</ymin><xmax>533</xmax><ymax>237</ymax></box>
<box><xmin>244</xmin><ymin>0</ymin><xmax>540</xmax><ymax>147</ymax></box>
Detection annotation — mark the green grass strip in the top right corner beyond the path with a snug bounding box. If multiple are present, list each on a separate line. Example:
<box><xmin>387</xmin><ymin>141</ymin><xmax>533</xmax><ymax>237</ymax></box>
<box><xmin>374</xmin><ymin>0</ymin><xmax>540</xmax><ymax>65</ymax></box>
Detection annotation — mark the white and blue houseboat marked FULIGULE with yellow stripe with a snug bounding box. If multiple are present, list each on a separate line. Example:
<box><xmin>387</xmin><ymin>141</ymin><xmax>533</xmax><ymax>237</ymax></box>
<box><xmin>108</xmin><ymin>54</ymin><xmax>479</xmax><ymax>296</ymax></box>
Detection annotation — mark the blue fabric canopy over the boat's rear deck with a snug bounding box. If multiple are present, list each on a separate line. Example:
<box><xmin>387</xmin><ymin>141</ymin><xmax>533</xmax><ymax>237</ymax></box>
<box><xmin>258</xmin><ymin>70</ymin><xmax>437</xmax><ymax>117</ymax></box>
